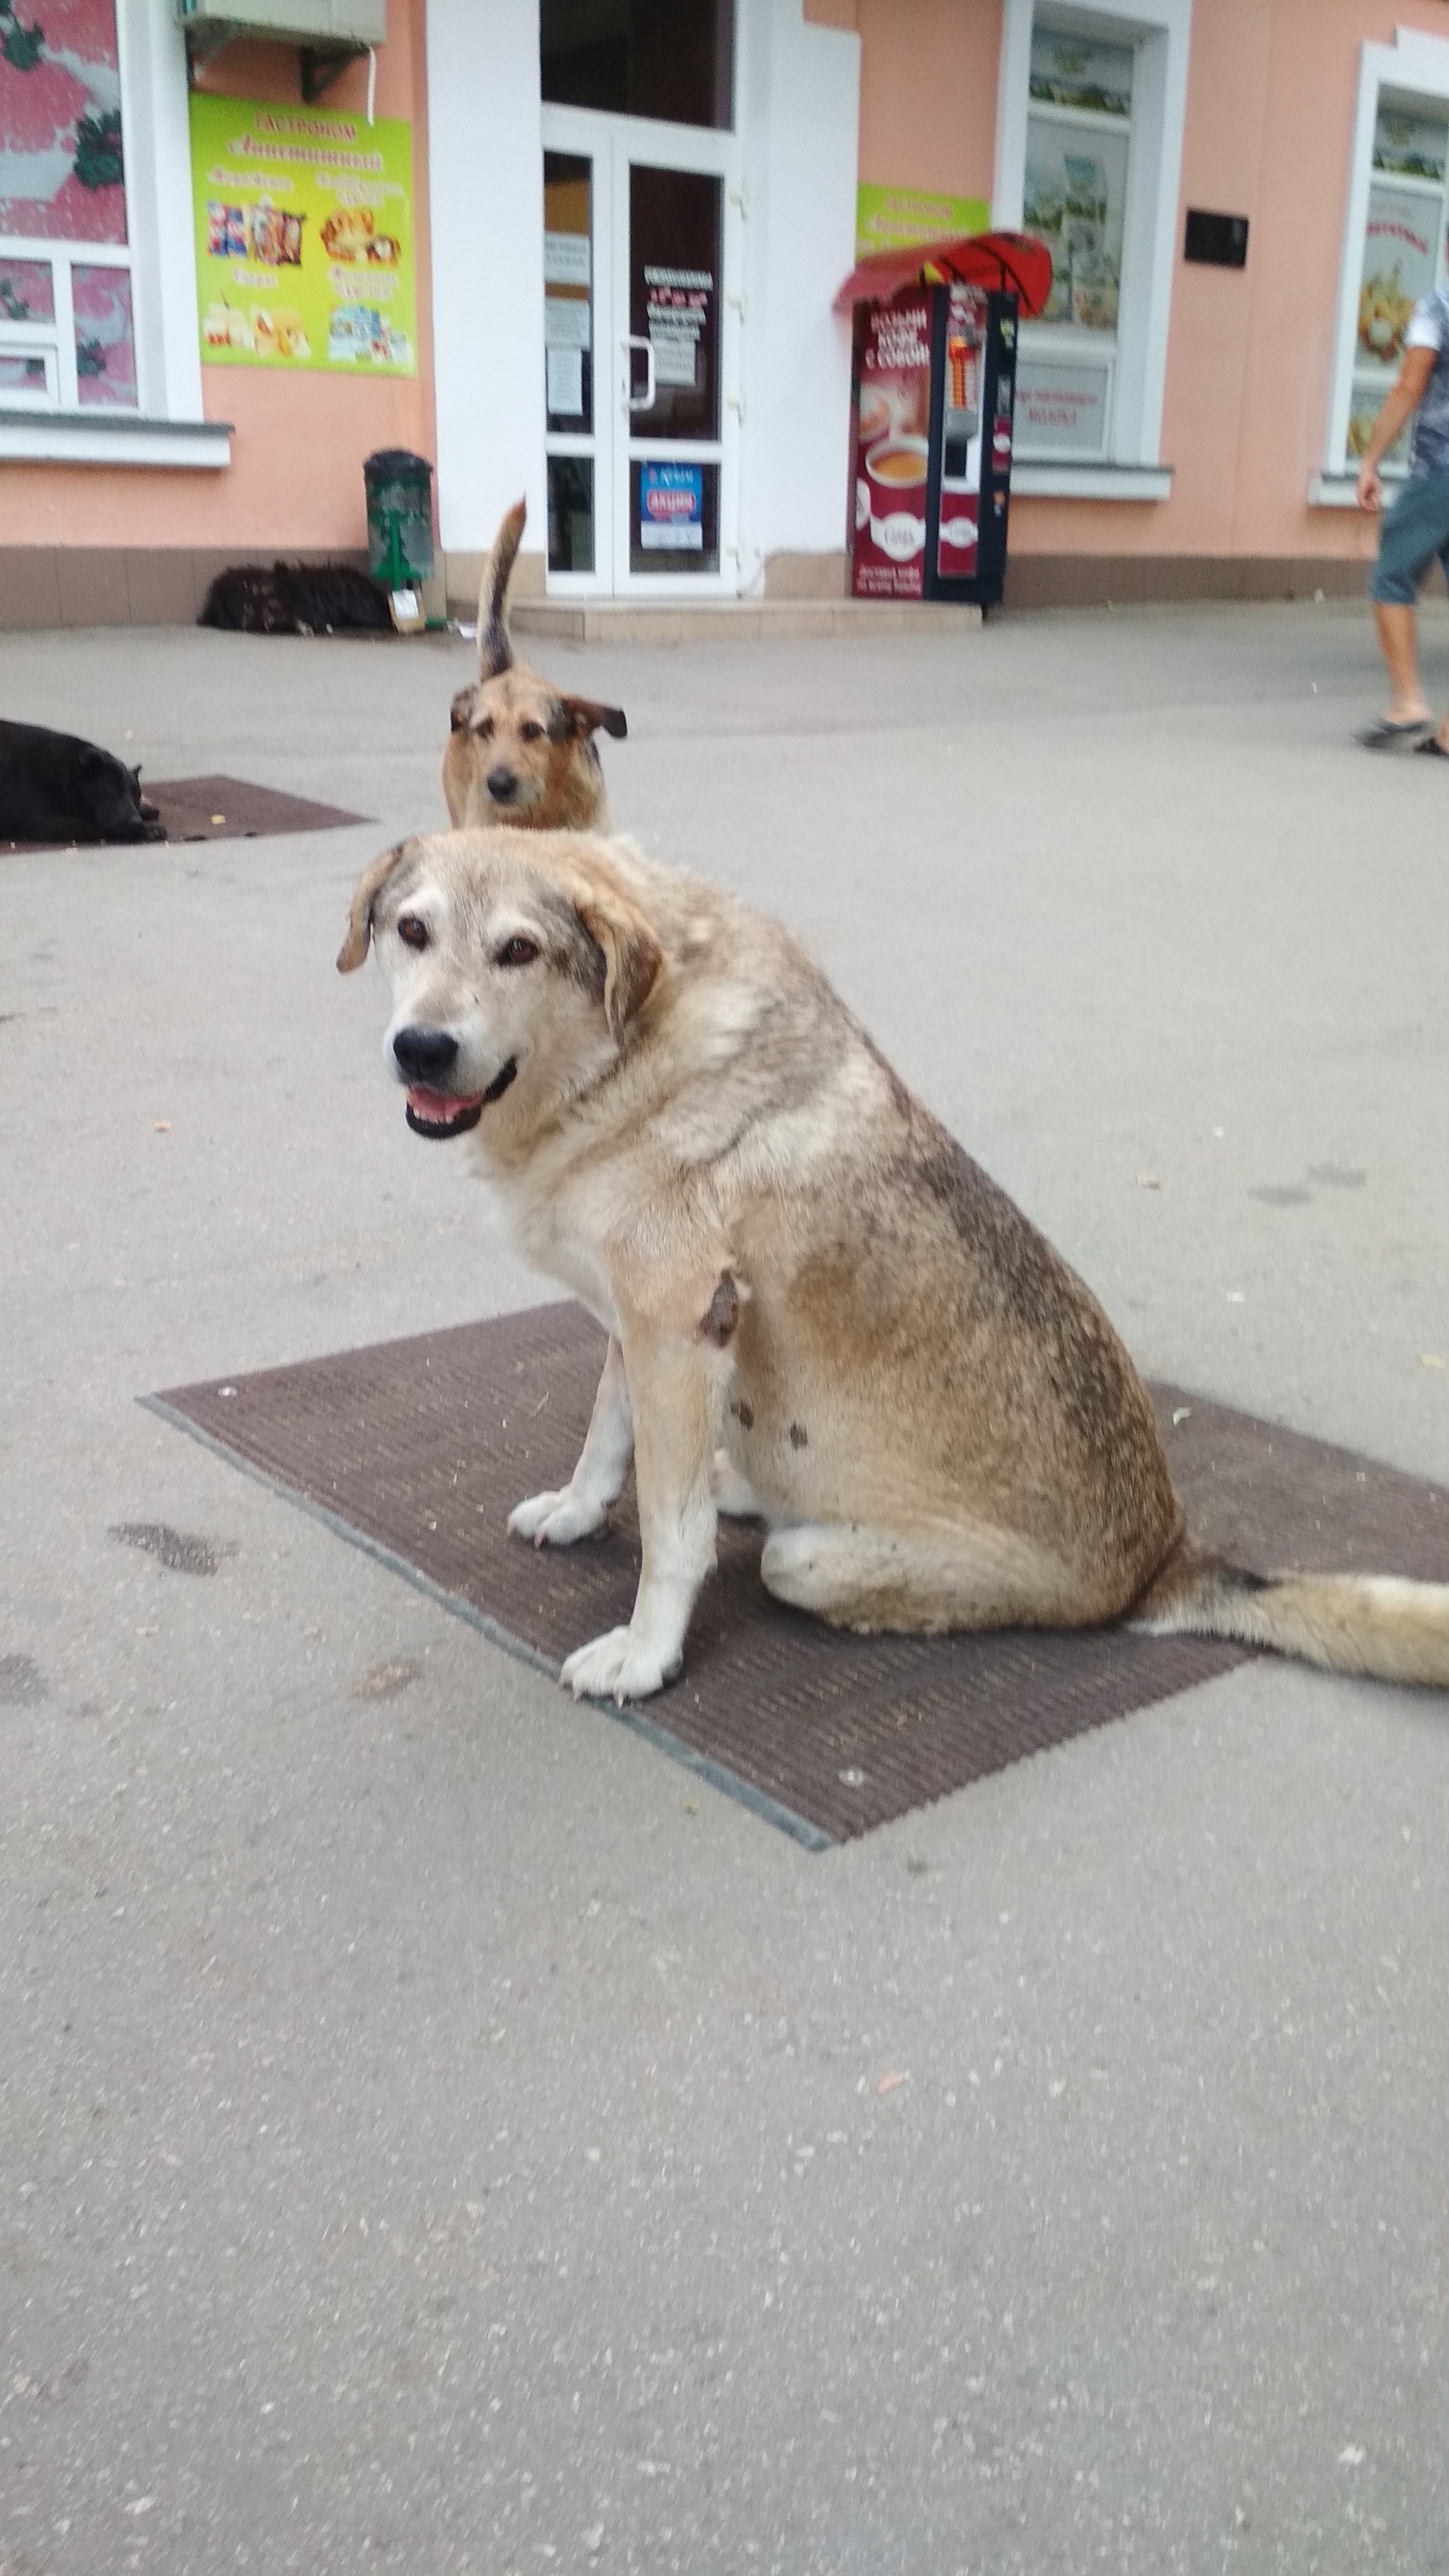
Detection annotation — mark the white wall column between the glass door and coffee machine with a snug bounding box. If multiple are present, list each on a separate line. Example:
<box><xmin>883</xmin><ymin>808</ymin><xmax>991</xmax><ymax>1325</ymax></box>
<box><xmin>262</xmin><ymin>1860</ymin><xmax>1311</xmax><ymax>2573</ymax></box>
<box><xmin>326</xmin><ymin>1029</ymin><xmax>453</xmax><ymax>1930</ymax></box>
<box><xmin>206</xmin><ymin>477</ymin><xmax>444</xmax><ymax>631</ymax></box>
<box><xmin>736</xmin><ymin>0</ymin><xmax>860</xmax><ymax>590</ymax></box>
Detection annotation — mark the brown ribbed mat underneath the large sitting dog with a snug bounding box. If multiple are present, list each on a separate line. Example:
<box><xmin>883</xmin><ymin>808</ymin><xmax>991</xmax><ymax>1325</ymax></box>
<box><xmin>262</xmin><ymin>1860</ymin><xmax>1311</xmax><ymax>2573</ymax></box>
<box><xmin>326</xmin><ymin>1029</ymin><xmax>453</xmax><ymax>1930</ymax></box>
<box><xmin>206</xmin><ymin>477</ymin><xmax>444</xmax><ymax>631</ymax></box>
<box><xmin>144</xmin><ymin>1306</ymin><xmax>1449</xmax><ymax>1850</ymax></box>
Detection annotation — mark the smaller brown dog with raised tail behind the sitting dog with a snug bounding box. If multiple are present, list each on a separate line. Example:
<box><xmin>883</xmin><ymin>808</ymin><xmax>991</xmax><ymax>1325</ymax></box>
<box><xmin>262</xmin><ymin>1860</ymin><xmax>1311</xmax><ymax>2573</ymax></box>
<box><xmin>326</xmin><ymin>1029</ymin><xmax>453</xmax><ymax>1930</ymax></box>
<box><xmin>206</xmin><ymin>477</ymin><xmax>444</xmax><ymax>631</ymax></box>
<box><xmin>443</xmin><ymin>500</ymin><xmax>628</xmax><ymax>832</ymax></box>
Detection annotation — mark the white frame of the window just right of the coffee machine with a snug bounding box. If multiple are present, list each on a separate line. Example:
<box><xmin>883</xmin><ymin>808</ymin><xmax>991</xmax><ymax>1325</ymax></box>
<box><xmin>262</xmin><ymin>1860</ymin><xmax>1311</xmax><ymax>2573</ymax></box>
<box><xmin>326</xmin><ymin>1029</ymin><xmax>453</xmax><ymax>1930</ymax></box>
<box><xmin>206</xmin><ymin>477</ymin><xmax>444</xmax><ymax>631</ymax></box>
<box><xmin>991</xmin><ymin>0</ymin><xmax>1191</xmax><ymax>500</ymax></box>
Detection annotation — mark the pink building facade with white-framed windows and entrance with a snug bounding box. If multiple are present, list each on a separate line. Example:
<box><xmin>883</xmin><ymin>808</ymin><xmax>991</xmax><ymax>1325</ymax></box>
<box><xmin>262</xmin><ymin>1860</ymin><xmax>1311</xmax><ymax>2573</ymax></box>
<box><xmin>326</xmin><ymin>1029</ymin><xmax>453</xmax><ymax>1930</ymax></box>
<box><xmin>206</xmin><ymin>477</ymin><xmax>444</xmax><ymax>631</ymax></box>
<box><xmin>0</xmin><ymin>0</ymin><xmax>1449</xmax><ymax>623</ymax></box>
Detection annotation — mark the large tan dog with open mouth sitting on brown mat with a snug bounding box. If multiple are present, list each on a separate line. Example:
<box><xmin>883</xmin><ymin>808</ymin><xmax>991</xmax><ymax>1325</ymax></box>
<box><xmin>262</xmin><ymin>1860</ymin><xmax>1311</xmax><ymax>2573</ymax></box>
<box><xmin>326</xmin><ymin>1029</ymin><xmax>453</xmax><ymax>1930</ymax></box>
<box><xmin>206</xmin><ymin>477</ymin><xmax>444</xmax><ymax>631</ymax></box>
<box><xmin>337</xmin><ymin>832</ymin><xmax>1449</xmax><ymax>1700</ymax></box>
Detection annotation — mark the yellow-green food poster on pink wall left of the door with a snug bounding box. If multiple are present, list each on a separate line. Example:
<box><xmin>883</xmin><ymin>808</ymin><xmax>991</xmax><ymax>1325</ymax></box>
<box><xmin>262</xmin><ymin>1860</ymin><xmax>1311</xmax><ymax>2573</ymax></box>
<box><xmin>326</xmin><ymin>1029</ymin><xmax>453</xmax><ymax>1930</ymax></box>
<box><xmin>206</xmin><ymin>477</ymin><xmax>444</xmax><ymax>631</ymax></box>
<box><xmin>190</xmin><ymin>96</ymin><xmax>417</xmax><ymax>376</ymax></box>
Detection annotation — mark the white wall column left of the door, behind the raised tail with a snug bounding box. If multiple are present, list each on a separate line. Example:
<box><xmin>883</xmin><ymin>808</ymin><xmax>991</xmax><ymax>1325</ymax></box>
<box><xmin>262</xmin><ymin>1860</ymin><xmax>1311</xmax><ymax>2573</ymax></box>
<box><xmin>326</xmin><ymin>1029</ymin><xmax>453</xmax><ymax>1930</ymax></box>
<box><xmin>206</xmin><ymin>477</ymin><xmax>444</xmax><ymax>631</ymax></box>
<box><xmin>427</xmin><ymin>0</ymin><xmax>548</xmax><ymax>554</ymax></box>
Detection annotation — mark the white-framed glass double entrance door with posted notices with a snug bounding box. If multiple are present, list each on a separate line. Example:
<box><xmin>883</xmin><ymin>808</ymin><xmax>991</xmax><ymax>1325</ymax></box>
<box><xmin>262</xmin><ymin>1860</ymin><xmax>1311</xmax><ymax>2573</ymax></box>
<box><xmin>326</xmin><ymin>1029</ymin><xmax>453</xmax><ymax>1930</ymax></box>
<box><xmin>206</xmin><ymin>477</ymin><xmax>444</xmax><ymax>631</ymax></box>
<box><xmin>543</xmin><ymin>105</ymin><xmax>741</xmax><ymax>597</ymax></box>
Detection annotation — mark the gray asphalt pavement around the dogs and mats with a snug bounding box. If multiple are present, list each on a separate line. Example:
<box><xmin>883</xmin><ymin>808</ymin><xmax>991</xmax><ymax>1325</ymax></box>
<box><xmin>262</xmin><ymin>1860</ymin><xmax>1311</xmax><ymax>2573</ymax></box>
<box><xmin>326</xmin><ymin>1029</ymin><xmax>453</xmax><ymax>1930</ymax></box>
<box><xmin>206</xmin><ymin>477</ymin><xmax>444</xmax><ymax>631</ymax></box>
<box><xmin>0</xmin><ymin>605</ymin><xmax>1449</xmax><ymax>2576</ymax></box>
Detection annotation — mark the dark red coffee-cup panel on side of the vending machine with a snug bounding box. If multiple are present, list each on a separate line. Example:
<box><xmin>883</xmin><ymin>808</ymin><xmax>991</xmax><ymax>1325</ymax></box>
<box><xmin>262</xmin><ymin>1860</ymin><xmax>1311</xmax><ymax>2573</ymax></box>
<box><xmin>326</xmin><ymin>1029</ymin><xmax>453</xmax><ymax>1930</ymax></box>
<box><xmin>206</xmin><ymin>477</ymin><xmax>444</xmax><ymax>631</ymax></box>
<box><xmin>852</xmin><ymin>297</ymin><xmax>932</xmax><ymax>600</ymax></box>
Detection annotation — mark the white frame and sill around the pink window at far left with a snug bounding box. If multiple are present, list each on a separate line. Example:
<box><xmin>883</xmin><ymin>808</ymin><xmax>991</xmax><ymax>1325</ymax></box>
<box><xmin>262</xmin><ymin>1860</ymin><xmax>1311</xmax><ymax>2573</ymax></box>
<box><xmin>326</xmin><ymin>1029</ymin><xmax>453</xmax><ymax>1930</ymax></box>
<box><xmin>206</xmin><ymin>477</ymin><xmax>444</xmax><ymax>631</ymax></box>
<box><xmin>0</xmin><ymin>0</ymin><xmax>231</xmax><ymax>468</ymax></box>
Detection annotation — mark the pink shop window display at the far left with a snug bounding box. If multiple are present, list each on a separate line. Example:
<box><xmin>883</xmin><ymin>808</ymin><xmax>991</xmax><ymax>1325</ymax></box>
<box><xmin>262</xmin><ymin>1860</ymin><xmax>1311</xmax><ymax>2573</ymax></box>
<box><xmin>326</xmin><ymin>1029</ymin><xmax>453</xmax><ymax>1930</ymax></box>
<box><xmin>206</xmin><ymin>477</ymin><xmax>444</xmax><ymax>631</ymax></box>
<box><xmin>0</xmin><ymin>0</ymin><xmax>137</xmax><ymax>410</ymax></box>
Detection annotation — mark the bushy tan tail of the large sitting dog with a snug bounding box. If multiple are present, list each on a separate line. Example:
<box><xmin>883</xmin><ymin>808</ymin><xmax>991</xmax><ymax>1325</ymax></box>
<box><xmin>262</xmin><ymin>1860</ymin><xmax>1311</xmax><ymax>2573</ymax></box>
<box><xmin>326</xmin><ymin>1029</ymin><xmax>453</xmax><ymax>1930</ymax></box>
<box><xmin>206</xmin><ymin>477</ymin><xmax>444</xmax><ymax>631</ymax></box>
<box><xmin>1133</xmin><ymin>1541</ymin><xmax>1449</xmax><ymax>1690</ymax></box>
